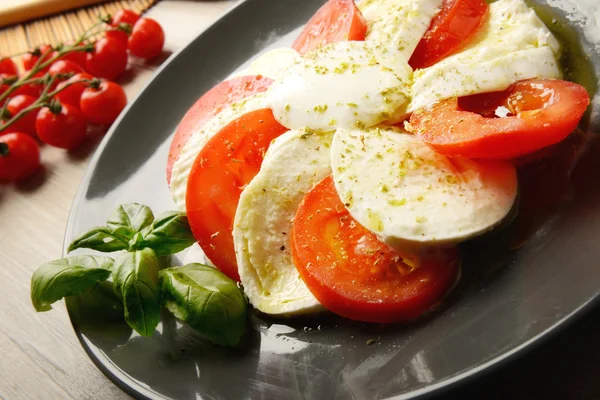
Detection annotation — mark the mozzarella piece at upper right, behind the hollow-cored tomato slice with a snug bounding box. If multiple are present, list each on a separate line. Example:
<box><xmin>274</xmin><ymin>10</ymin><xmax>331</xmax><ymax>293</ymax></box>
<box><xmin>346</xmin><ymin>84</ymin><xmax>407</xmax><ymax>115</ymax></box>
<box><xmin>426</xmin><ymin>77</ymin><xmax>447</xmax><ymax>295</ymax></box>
<box><xmin>409</xmin><ymin>0</ymin><xmax>561</xmax><ymax>111</ymax></box>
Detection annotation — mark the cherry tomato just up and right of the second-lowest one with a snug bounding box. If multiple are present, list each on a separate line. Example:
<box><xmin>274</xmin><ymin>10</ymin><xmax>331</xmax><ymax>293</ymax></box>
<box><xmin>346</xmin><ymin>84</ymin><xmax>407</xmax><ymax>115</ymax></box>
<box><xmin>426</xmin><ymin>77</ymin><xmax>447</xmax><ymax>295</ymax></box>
<box><xmin>79</xmin><ymin>81</ymin><xmax>127</xmax><ymax>125</ymax></box>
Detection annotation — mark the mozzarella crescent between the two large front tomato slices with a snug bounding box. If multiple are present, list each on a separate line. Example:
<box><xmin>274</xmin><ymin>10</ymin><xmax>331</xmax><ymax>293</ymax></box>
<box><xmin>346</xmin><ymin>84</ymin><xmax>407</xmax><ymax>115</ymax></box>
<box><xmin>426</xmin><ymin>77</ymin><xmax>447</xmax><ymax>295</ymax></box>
<box><xmin>233</xmin><ymin>130</ymin><xmax>332</xmax><ymax>315</ymax></box>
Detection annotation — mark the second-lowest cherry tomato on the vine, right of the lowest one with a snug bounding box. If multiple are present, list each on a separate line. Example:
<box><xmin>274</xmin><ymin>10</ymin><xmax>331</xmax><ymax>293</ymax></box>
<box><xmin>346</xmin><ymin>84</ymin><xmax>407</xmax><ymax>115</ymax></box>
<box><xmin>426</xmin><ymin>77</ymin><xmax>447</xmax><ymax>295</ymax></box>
<box><xmin>35</xmin><ymin>104</ymin><xmax>87</xmax><ymax>150</ymax></box>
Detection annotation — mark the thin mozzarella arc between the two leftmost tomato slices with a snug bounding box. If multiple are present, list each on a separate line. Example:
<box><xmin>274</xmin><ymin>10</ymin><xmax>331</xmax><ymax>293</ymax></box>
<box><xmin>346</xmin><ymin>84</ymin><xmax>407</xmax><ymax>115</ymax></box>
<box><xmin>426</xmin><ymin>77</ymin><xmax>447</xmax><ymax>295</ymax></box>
<box><xmin>171</xmin><ymin>93</ymin><xmax>266</xmax><ymax>210</ymax></box>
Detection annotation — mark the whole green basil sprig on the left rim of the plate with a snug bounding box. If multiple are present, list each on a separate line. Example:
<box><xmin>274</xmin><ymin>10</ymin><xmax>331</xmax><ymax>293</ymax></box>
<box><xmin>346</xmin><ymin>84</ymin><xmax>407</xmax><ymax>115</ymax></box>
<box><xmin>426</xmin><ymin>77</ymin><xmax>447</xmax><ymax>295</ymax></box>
<box><xmin>31</xmin><ymin>203</ymin><xmax>247</xmax><ymax>346</ymax></box>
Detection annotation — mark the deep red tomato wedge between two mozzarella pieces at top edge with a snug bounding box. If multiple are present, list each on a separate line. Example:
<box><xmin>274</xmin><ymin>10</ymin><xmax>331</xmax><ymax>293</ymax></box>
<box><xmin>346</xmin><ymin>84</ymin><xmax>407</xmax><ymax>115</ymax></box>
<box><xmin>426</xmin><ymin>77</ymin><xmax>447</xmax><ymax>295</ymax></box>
<box><xmin>408</xmin><ymin>0</ymin><xmax>488</xmax><ymax>69</ymax></box>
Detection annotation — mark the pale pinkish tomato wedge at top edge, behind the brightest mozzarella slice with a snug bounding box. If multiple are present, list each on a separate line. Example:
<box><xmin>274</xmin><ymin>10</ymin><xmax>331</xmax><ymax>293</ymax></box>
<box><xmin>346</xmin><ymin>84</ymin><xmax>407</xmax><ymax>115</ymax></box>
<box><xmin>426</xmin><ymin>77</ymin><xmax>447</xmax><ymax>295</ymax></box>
<box><xmin>292</xmin><ymin>0</ymin><xmax>367</xmax><ymax>54</ymax></box>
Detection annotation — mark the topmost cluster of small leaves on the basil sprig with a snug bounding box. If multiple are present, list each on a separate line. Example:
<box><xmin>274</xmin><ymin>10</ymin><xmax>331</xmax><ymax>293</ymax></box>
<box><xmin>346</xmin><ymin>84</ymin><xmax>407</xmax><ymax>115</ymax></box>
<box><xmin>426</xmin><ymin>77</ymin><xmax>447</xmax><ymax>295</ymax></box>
<box><xmin>68</xmin><ymin>203</ymin><xmax>195</xmax><ymax>256</ymax></box>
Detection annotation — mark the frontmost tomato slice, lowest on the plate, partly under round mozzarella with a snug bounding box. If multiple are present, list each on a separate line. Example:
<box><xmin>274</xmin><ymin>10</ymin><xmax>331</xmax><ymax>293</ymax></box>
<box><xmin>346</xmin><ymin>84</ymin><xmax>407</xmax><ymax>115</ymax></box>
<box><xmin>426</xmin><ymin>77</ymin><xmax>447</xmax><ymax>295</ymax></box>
<box><xmin>291</xmin><ymin>176</ymin><xmax>459</xmax><ymax>323</ymax></box>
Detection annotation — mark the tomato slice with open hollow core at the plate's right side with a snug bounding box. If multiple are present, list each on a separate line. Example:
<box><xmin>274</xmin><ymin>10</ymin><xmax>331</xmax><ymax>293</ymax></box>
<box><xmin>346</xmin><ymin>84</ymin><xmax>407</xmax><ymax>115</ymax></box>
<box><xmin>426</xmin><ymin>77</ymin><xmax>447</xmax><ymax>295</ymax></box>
<box><xmin>407</xmin><ymin>79</ymin><xmax>590</xmax><ymax>159</ymax></box>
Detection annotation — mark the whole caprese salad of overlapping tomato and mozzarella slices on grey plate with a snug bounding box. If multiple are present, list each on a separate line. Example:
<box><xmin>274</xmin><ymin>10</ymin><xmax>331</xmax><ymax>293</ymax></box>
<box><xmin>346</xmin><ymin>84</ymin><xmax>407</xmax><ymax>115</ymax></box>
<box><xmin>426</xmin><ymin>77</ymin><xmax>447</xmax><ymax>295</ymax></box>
<box><xmin>167</xmin><ymin>0</ymin><xmax>589</xmax><ymax>322</ymax></box>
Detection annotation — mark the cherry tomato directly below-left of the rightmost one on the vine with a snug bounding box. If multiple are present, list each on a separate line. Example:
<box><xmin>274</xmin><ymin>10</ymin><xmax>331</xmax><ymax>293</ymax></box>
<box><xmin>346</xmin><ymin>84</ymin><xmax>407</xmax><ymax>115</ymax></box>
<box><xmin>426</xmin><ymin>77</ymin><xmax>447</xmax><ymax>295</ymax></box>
<box><xmin>85</xmin><ymin>37</ymin><xmax>127</xmax><ymax>81</ymax></box>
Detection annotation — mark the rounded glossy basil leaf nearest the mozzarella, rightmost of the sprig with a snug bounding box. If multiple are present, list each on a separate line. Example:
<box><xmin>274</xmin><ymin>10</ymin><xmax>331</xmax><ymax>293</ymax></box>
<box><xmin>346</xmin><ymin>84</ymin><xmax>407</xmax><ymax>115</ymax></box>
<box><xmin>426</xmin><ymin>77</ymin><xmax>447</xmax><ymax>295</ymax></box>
<box><xmin>160</xmin><ymin>264</ymin><xmax>247</xmax><ymax>346</ymax></box>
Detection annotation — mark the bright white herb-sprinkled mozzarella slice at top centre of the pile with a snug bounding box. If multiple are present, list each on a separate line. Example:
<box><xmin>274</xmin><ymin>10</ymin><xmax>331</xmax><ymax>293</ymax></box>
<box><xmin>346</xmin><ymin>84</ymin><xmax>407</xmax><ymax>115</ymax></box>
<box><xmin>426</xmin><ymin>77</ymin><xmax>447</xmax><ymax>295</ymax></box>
<box><xmin>267</xmin><ymin>41</ymin><xmax>412</xmax><ymax>131</ymax></box>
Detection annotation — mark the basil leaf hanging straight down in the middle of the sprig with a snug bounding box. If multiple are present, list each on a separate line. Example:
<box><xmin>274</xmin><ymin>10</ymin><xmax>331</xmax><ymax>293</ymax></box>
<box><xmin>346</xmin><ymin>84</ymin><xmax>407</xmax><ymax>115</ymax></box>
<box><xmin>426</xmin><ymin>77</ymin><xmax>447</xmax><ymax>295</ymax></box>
<box><xmin>113</xmin><ymin>248</ymin><xmax>160</xmax><ymax>336</ymax></box>
